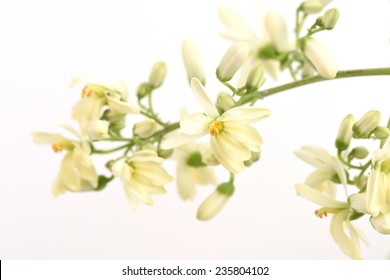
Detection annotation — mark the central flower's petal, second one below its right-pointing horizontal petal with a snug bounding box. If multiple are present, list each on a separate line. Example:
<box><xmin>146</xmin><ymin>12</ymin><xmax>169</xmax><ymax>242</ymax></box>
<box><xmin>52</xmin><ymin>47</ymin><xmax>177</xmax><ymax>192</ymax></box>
<box><xmin>215</xmin><ymin>132</ymin><xmax>252</xmax><ymax>161</ymax></box>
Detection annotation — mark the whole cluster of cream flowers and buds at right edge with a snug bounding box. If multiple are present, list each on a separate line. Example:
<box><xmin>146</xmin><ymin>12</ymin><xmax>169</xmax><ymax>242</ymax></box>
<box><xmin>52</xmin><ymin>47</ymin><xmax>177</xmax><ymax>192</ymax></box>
<box><xmin>296</xmin><ymin>110</ymin><xmax>390</xmax><ymax>259</ymax></box>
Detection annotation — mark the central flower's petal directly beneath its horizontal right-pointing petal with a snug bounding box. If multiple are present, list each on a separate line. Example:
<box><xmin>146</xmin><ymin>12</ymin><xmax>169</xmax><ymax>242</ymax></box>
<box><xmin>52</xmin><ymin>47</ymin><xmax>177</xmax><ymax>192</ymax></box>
<box><xmin>224</xmin><ymin>122</ymin><xmax>263</xmax><ymax>147</ymax></box>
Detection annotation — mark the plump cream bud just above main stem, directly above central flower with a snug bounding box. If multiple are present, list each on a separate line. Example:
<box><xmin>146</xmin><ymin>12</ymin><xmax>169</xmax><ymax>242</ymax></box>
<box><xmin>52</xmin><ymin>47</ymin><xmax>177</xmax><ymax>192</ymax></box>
<box><xmin>217</xmin><ymin>41</ymin><xmax>249</xmax><ymax>82</ymax></box>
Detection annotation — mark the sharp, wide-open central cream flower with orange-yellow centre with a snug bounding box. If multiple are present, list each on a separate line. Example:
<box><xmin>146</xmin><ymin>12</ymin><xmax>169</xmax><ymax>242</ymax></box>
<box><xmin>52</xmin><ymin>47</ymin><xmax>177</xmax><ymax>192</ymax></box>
<box><xmin>162</xmin><ymin>78</ymin><xmax>270</xmax><ymax>173</ymax></box>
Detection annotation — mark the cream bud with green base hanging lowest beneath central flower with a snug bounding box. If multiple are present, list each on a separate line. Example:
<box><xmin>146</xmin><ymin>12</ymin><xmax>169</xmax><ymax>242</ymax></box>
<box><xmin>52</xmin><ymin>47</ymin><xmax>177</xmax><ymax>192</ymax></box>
<box><xmin>197</xmin><ymin>182</ymin><xmax>234</xmax><ymax>221</ymax></box>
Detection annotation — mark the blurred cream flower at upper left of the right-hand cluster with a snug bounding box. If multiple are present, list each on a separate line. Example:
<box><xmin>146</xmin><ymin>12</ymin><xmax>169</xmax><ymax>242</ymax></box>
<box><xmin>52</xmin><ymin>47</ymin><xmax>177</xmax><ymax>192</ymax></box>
<box><xmin>295</xmin><ymin>146</ymin><xmax>347</xmax><ymax>197</ymax></box>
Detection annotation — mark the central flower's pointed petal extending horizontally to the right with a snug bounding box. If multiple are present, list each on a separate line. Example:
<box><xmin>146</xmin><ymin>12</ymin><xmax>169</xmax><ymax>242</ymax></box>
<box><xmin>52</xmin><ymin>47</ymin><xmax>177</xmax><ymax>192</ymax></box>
<box><xmin>218</xmin><ymin>107</ymin><xmax>271</xmax><ymax>124</ymax></box>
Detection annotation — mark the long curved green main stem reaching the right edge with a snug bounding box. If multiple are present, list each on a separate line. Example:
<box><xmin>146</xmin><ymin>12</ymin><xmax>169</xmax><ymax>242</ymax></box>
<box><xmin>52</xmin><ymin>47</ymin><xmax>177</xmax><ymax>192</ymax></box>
<box><xmin>236</xmin><ymin>67</ymin><xmax>390</xmax><ymax>106</ymax></box>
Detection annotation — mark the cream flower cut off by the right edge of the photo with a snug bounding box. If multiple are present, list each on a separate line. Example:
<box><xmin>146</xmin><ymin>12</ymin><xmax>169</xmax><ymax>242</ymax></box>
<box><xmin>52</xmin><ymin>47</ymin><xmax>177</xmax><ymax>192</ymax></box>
<box><xmin>366</xmin><ymin>138</ymin><xmax>390</xmax><ymax>217</ymax></box>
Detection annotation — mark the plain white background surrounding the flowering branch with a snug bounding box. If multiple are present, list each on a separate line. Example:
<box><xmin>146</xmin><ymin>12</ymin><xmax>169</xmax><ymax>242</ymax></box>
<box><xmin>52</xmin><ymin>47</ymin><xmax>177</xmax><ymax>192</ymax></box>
<box><xmin>0</xmin><ymin>0</ymin><xmax>390</xmax><ymax>259</ymax></box>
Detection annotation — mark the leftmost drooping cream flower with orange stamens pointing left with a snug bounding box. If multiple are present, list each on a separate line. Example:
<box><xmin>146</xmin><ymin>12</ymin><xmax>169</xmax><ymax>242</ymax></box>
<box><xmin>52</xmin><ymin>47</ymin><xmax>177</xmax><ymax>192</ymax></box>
<box><xmin>32</xmin><ymin>126</ymin><xmax>98</xmax><ymax>196</ymax></box>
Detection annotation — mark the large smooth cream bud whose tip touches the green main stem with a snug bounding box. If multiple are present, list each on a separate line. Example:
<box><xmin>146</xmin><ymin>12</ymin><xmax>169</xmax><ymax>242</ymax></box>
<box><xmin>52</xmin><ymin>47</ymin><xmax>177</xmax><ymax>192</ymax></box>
<box><xmin>303</xmin><ymin>37</ymin><xmax>337</xmax><ymax>79</ymax></box>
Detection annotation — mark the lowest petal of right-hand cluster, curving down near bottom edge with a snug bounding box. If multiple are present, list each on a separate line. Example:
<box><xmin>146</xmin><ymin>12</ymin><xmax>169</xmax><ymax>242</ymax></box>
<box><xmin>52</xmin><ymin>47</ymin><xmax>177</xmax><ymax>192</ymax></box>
<box><xmin>330</xmin><ymin>209</ymin><xmax>361</xmax><ymax>259</ymax></box>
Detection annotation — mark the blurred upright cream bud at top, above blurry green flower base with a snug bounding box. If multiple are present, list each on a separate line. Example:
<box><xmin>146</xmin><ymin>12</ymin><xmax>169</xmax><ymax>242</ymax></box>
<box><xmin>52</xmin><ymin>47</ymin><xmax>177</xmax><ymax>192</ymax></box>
<box><xmin>264</xmin><ymin>11</ymin><xmax>289</xmax><ymax>53</ymax></box>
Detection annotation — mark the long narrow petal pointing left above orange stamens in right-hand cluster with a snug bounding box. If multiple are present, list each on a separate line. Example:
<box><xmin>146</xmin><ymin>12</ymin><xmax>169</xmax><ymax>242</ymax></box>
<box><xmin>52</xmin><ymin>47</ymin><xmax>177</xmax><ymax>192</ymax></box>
<box><xmin>295</xmin><ymin>184</ymin><xmax>348</xmax><ymax>208</ymax></box>
